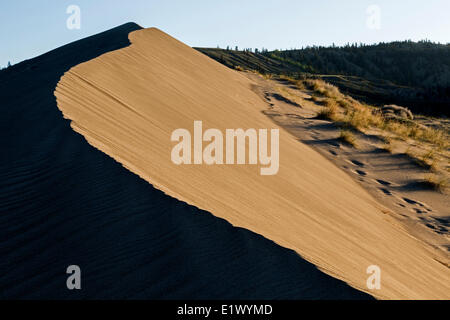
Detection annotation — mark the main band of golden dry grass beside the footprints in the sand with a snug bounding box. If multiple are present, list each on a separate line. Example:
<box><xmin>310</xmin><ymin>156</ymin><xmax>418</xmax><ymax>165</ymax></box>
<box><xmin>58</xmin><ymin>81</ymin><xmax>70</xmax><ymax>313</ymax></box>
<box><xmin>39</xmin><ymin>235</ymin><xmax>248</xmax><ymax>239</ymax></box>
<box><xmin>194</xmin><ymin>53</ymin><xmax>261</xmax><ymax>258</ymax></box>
<box><xmin>294</xmin><ymin>80</ymin><xmax>449</xmax><ymax>184</ymax></box>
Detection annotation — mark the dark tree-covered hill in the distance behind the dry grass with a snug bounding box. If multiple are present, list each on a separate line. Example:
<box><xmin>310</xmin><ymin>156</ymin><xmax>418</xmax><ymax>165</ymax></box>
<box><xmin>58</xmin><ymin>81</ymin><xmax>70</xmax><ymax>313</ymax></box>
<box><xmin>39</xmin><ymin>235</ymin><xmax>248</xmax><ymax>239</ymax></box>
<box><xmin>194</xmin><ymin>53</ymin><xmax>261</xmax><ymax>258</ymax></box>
<box><xmin>198</xmin><ymin>41</ymin><xmax>450</xmax><ymax>116</ymax></box>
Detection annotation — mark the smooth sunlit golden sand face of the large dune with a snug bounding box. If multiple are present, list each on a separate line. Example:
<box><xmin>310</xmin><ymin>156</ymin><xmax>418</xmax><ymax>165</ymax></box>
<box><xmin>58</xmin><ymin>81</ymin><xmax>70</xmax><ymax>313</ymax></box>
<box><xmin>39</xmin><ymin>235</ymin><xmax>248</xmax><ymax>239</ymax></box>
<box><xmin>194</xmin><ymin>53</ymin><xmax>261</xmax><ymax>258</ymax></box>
<box><xmin>55</xmin><ymin>29</ymin><xmax>450</xmax><ymax>299</ymax></box>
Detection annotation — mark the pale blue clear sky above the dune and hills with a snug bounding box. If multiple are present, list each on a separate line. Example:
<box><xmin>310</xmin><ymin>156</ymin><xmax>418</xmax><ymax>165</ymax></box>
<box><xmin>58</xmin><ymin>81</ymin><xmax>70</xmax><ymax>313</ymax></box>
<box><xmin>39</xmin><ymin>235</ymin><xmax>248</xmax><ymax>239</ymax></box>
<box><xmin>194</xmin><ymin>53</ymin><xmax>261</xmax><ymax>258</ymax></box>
<box><xmin>0</xmin><ymin>0</ymin><xmax>450</xmax><ymax>66</ymax></box>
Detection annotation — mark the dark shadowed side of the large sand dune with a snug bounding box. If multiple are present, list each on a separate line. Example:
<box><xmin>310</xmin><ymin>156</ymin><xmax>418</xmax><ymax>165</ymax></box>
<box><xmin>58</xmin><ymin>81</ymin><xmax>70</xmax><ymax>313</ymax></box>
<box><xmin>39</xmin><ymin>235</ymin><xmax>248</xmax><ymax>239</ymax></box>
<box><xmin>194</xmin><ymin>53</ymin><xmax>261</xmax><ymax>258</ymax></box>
<box><xmin>0</xmin><ymin>24</ymin><xmax>370</xmax><ymax>299</ymax></box>
